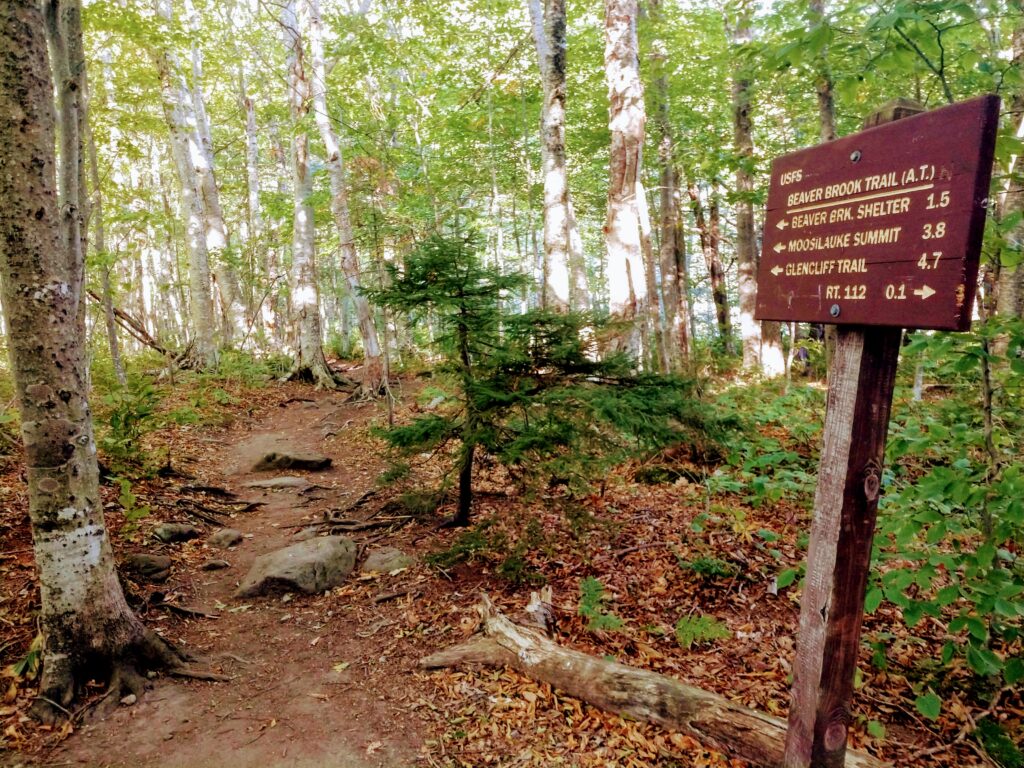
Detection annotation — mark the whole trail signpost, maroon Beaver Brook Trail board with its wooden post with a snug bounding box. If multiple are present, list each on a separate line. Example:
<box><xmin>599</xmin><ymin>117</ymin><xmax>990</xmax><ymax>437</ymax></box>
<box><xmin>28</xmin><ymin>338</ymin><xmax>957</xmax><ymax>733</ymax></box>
<box><xmin>757</xmin><ymin>96</ymin><xmax>999</xmax><ymax>768</ymax></box>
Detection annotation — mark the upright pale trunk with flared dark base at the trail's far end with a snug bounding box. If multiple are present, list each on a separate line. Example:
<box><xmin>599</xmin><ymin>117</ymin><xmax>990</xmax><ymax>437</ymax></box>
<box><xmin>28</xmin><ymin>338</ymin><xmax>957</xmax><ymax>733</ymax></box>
<box><xmin>282</xmin><ymin>0</ymin><xmax>338</xmax><ymax>389</ymax></box>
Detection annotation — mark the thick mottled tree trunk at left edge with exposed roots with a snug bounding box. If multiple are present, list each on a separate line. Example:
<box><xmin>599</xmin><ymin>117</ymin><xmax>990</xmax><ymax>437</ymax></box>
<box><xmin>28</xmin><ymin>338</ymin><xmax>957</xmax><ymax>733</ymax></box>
<box><xmin>0</xmin><ymin>0</ymin><xmax>179</xmax><ymax>717</ymax></box>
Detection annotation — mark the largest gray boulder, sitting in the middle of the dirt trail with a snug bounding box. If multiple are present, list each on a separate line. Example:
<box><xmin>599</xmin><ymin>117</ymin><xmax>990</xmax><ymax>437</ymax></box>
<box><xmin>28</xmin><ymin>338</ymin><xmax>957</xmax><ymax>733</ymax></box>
<box><xmin>236</xmin><ymin>536</ymin><xmax>356</xmax><ymax>597</ymax></box>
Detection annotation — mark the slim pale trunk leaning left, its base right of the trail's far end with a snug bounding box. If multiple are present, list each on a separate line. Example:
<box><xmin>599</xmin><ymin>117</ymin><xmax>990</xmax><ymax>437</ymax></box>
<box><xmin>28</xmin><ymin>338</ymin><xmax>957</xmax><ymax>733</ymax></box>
<box><xmin>302</xmin><ymin>0</ymin><xmax>388</xmax><ymax>396</ymax></box>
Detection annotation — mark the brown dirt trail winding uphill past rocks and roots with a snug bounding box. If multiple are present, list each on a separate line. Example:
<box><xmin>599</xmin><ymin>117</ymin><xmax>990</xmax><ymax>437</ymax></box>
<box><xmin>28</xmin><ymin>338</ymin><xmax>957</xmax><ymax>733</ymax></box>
<box><xmin>48</xmin><ymin>392</ymin><xmax>429</xmax><ymax>768</ymax></box>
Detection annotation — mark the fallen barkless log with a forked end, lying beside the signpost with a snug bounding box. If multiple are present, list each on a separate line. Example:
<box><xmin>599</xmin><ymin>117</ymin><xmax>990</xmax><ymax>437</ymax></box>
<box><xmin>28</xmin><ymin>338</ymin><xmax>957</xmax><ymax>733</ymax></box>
<box><xmin>420</xmin><ymin>595</ymin><xmax>887</xmax><ymax>768</ymax></box>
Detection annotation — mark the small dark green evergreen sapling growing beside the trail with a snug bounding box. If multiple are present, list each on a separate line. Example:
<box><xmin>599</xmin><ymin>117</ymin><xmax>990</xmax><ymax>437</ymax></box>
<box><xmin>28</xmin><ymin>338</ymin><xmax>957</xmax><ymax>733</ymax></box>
<box><xmin>369</xmin><ymin>236</ymin><xmax>734</xmax><ymax>528</ymax></box>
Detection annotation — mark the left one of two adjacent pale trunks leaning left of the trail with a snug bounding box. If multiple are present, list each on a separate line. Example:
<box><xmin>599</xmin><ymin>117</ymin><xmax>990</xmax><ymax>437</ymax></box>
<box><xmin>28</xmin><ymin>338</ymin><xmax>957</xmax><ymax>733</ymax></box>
<box><xmin>154</xmin><ymin>0</ymin><xmax>217</xmax><ymax>367</ymax></box>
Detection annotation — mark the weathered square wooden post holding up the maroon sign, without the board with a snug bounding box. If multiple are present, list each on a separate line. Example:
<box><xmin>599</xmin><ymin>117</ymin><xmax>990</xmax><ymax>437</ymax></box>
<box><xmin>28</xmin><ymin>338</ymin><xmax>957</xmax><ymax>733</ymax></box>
<box><xmin>782</xmin><ymin>99</ymin><xmax>922</xmax><ymax>768</ymax></box>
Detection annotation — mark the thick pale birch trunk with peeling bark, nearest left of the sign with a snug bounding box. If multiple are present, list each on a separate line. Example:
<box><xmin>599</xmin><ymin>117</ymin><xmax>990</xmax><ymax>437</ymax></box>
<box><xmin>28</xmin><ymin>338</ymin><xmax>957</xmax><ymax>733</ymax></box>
<box><xmin>604</xmin><ymin>0</ymin><xmax>648</xmax><ymax>356</ymax></box>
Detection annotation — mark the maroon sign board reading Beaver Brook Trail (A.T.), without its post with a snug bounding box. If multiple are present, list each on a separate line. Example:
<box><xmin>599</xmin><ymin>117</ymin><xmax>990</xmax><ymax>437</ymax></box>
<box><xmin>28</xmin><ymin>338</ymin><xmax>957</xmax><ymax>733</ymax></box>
<box><xmin>756</xmin><ymin>96</ymin><xmax>999</xmax><ymax>331</ymax></box>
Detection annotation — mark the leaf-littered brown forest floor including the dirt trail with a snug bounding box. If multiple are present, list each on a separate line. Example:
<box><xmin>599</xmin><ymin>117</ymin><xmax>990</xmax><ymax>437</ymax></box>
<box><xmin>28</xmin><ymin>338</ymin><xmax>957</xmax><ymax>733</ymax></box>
<box><xmin>0</xmin><ymin>370</ymin><xmax>1021</xmax><ymax>768</ymax></box>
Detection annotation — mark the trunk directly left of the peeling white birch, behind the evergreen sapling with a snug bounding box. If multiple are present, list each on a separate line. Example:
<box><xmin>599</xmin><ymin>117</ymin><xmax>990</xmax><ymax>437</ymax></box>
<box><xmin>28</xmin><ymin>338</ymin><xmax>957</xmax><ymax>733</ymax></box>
<box><xmin>528</xmin><ymin>0</ymin><xmax>590</xmax><ymax>310</ymax></box>
